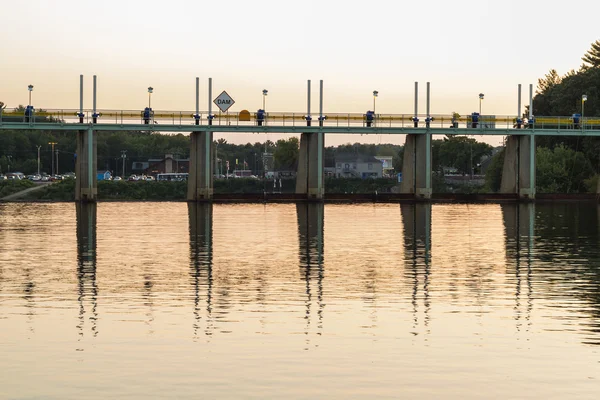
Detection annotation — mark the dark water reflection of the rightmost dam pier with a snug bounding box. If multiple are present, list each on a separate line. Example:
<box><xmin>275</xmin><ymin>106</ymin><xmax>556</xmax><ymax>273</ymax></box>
<box><xmin>501</xmin><ymin>203</ymin><xmax>535</xmax><ymax>331</ymax></box>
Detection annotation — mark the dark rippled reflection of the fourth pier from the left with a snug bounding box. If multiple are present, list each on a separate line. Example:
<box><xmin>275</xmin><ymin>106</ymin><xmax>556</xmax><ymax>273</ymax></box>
<box><xmin>400</xmin><ymin>203</ymin><xmax>431</xmax><ymax>335</ymax></box>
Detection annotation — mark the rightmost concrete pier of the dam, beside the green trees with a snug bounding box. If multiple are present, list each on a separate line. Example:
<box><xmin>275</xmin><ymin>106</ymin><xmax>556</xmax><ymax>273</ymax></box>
<box><xmin>500</xmin><ymin>135</ymin><xmax>535</xmax><ymax>199</ymax></box>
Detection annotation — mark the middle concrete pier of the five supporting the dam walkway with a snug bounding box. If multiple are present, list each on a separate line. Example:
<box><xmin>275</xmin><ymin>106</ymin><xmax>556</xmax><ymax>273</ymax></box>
<box><xmin>296</xmin><ymin>132</ymin><xmax>325</xmax><ymax>200</ymax></box>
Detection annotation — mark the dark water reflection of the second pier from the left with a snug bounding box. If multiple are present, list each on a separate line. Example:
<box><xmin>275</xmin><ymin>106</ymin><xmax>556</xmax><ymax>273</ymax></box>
<box><xmin>188</xmin><ymin>203</ymin><xmax>213</xmax><ymax>336</ymax></box>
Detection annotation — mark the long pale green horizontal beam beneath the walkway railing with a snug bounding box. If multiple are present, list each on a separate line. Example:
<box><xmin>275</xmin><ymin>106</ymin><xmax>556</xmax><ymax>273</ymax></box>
<box><xmin>0</xmin><ymin>122</ymin><xmax>600</xmax><ymax>136</ymax></box>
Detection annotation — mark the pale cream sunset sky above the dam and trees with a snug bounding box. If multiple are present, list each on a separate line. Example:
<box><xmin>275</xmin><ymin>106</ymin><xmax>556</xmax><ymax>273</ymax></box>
<box><xmin>0</xmin><ymin>0</ymin><xmax>600</xmax><ymax>145</ymax></box>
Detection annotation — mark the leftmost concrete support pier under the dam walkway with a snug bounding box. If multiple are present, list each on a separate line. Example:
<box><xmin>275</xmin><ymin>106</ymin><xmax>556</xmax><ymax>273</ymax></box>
<box><xmin>75</xmin><ymin>129</ymin><xmax>98</xmax><ymax>202</ymax></box>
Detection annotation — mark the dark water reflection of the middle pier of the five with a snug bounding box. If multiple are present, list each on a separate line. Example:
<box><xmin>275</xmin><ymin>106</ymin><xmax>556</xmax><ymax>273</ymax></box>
<box><xmin>296</xmin><ymin>203</ymin><xmax>324</xmax><ymax>335</ymax></box>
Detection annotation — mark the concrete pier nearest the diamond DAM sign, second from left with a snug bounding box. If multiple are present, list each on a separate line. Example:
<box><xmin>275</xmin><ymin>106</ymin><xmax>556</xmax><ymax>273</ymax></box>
<box><xmin>187</xmin><ymin>132</ymin><xmax>213</xmax><ymax>201</ymax></box>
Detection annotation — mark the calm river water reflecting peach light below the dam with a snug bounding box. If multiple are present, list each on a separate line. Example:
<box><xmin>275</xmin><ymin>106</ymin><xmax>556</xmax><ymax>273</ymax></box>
<box><xmin>0</xmin><ymin>203</ymin><xmax>600</xmax><ymax>399</ymax></box>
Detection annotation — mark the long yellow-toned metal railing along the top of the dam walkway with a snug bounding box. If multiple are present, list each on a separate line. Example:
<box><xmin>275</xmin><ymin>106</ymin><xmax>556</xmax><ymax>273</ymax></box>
<box><xmin>0</xmin><ymin>109</ymin><xmax>600</xmax><ymax>133</ymax></box>
